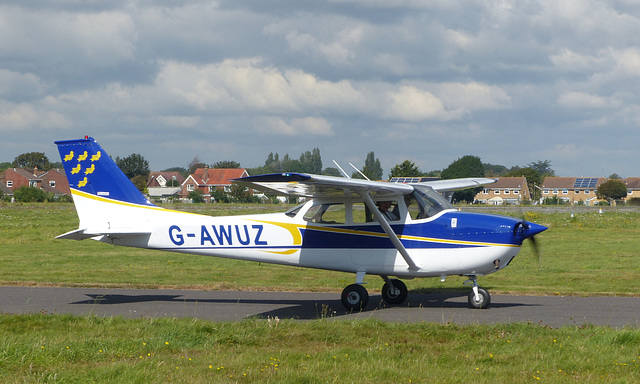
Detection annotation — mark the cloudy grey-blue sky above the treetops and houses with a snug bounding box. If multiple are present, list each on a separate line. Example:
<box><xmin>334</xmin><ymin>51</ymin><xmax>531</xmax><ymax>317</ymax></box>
<box><xmin>0</xmin><ymin>0</ymin><xmax>640</xmax><ymax>177</ymax></box>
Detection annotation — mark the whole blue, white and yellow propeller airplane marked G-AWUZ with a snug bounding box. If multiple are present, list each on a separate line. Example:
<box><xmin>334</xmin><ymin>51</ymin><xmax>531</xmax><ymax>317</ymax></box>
<box><xmin>55</xmin><ymin>136</ymin><xmax>547</xmax><ymax>311</ymax></box>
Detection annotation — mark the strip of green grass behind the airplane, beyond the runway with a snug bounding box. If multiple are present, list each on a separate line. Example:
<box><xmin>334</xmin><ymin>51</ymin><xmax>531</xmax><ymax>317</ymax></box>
<box><xmin>0</xmin><ymin>204</ymin><xmax>640</xmax><ymax>295</ymax></box>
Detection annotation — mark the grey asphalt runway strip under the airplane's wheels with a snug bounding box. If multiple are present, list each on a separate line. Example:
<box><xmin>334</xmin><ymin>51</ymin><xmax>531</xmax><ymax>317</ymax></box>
<box><xmin>0</xmin><ymin>287</ymin><xmax>640</xmax><ymax>327</ymax></box>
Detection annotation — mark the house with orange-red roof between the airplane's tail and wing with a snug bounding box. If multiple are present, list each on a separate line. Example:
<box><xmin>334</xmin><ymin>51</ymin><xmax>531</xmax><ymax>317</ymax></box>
<box><xmin>180</xmin><ymin>168</ymin><xmax>249</xmax><ymax>202</ymax></box>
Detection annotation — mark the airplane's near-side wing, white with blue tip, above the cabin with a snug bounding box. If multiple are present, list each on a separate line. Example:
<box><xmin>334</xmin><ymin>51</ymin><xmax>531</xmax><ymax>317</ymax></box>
<box><xmin>232</xmin><ymin>173</ymin><xmax>413</xmax><ymax>197</ymax></box>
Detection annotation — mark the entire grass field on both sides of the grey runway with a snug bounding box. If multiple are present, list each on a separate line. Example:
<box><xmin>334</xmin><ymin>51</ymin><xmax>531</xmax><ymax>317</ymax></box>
<box><xmin>0</xmin><ymin>204</ymin><xmax>640</xmax><ymax>383</ymax></box>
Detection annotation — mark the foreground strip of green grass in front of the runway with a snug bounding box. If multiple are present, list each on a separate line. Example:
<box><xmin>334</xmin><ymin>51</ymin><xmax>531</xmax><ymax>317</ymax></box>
<box><xmin>0</xmin><ymin>314</ymin><xmax>640</xmax><ymax>383</ymax></box>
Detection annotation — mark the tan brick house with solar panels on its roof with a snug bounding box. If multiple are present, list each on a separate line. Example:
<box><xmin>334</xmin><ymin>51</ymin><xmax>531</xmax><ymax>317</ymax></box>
<box><xmin>542</xmin><ymin>177</ymin><xmax>606</xmax><ymax>205</ymax></box>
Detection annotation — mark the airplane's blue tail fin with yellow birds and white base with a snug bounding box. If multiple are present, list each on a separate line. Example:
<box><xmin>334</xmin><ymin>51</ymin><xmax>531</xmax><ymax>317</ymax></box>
<box><xmin>55</xmin><ymin>136</ymin><xmax>157</xmax><ymax>231</ymax></box>
